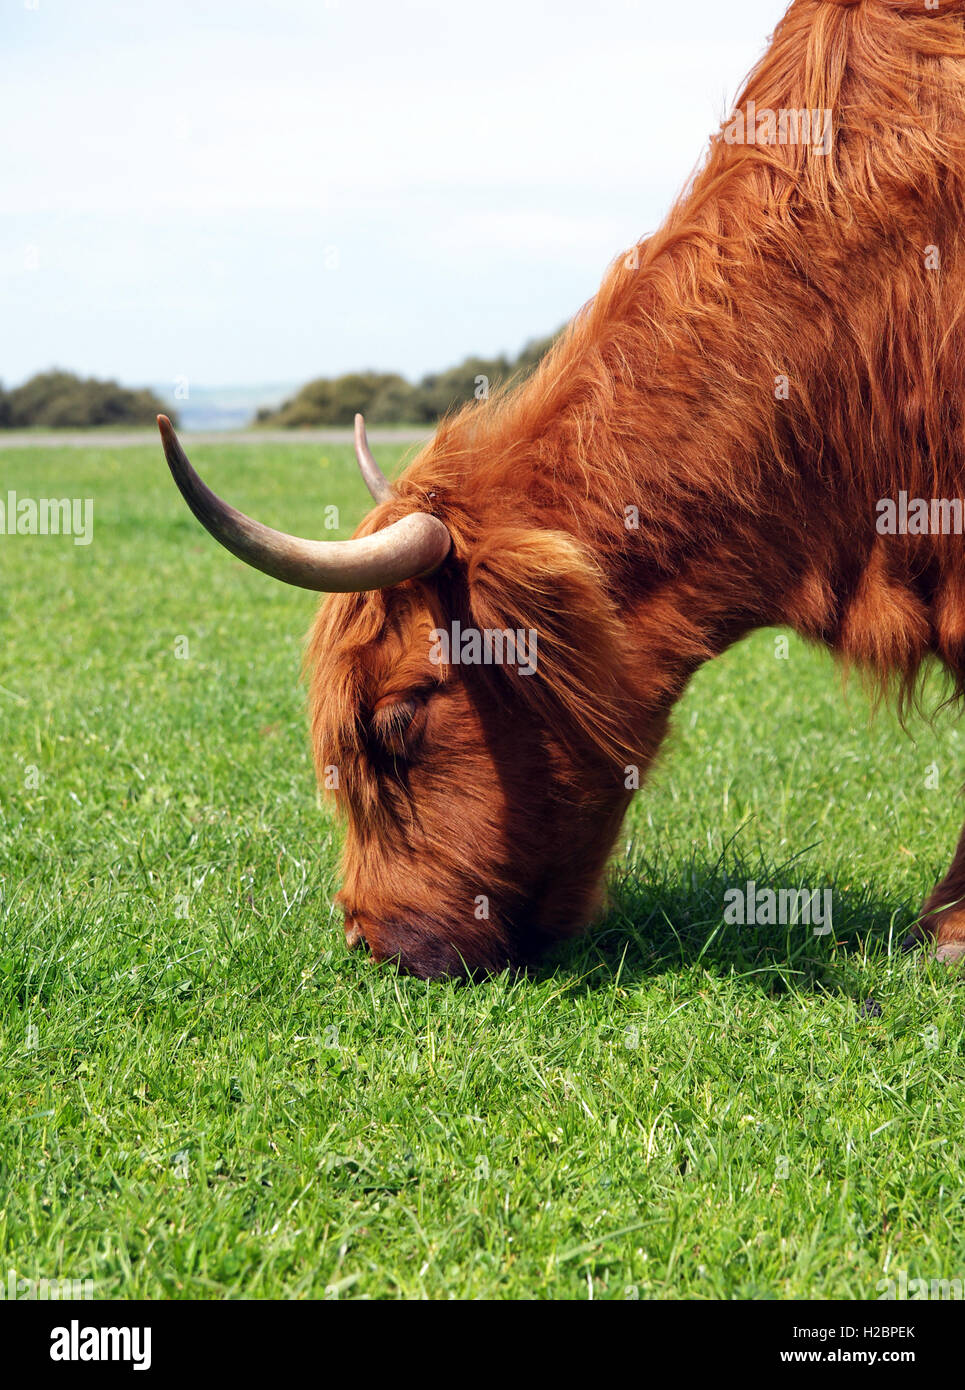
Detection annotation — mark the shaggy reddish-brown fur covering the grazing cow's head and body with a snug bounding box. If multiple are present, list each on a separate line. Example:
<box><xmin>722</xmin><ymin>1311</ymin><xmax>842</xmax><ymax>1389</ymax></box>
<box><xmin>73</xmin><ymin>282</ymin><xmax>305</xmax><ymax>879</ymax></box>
<box><xmin>310</xmin><ymin>0</ymin><xmax>965</xmax><ymax>976</ymax></box>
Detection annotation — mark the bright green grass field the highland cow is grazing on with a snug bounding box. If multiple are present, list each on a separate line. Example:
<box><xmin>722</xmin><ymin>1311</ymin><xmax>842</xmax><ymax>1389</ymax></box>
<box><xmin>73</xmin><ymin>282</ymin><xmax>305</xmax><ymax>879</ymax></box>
<box><xmin>0</xmin><ymin>442</ymin><xmax>965</xmax><ymax>1298</ymax></box>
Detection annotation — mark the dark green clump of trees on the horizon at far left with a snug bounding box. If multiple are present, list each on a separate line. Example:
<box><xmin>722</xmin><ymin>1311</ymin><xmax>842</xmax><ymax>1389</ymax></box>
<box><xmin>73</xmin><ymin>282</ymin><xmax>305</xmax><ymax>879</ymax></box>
<box><xmin>0</xmin><ymin>370</ymin><xmax>177</xmax><ymax>430</ymax></box>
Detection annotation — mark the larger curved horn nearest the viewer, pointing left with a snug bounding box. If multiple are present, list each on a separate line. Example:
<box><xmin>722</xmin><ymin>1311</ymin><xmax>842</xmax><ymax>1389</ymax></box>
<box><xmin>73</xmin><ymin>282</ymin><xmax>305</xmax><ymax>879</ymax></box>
<box><xmin>157</xmin><ymin>416</ymin><xmax>452</xmax><ymax>594</ymax></box>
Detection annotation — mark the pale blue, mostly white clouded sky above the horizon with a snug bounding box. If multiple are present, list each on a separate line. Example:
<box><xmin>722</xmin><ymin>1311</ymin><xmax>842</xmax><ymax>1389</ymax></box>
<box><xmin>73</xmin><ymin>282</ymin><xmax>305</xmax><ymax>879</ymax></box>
<box><xmin>0</xmin><ymin>0</ymin><xmax>786</xmax><ymax>386</ymax></box>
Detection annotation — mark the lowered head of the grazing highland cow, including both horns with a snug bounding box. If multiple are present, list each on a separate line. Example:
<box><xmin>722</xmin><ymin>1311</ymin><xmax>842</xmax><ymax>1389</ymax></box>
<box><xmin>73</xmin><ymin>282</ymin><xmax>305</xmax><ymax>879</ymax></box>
<box><xmin>161</xmin><ymin>417</ymin><xmax>663</xmax><ymax>977</ymax></box>
